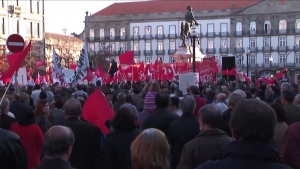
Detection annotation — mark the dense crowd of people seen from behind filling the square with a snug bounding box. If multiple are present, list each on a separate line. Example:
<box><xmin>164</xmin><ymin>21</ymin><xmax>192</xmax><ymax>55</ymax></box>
<box><xmin>0</xmin><ymin>81</ymin><xmax>300</xmax><ymax>169</ymax></box>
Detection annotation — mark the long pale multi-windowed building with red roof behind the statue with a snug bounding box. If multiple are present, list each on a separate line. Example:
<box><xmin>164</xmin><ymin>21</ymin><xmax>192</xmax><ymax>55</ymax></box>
<box><xmin>84</xmin><ymin>0</ymin><xmax>300</xmax><ymax>80</ymax></box>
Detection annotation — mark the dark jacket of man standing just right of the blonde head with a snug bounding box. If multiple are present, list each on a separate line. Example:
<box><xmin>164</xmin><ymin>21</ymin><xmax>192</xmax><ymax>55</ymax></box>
<box><xmin>169</xmin><ymin>114</ymin><xmax>200</xmax><ymax>169</ymax></box>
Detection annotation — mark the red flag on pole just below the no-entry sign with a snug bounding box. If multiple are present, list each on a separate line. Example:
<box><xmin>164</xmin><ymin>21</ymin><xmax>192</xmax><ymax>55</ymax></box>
<box><xmin>0</xmin><ymin>41</ymin><xmax>31</xmax><ymax>80</ymax></box>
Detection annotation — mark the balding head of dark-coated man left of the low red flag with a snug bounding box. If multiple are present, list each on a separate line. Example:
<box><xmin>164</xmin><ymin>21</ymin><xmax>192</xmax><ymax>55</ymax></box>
<box><xmin>64</xmin><ymin>98</ymin><xmax>81</xmax><ymax>117</ymax></box>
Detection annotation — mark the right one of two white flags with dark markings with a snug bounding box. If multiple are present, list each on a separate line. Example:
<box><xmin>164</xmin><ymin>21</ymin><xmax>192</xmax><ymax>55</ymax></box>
<box><xmin>72</xmin><ymin>42</ymin><xmax>90</xmax><ymax>87</ymax></box>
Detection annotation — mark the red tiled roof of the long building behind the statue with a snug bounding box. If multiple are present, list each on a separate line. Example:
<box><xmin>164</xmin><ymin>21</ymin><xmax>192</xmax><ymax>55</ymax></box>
<box><xmin>93</xmin><ymin>0</ymin><xmax>260</xmax><ymax>16</ymax></box>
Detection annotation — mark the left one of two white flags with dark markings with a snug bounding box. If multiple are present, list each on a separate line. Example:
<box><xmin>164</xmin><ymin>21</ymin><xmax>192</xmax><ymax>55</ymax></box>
<box><xmin>52</xmin><ymin>47</ymin><xmax>65</xmax><ymax>83</ymax></box>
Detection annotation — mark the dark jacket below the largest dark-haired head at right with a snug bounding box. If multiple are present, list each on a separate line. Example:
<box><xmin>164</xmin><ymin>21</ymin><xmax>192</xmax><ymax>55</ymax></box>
<box><xmin>197</xmin><ymin>141</ymin><xmax>291</xmax><ymax>169</ymax></box>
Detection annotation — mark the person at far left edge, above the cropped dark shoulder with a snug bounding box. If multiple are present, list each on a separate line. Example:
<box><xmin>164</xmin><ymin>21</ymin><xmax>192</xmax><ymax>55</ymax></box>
<box><xmin>0</xmin><ymin>98</ymin><xmax>16</xmax><ymax>130</ymax></box>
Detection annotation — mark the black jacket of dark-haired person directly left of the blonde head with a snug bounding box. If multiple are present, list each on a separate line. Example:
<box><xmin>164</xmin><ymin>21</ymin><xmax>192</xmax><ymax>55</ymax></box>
<box><xmin>104</xmin><ymin>130</ymin><xmax>139</xmax><ymax>169</ymax></box>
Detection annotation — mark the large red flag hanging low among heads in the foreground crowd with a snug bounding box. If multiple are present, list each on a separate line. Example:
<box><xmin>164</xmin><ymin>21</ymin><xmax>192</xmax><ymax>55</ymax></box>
<box><xmin>82</xmin><ymin>88</ymin><xmax>114</xmax><ymax>134</ymax></box>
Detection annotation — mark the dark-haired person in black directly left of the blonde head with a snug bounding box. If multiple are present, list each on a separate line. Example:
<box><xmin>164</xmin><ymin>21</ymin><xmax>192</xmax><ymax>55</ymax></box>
<box><xmin>104</xmin><ymin>108</ymin><xmax>139</xmax><ymax>169</ymax></box>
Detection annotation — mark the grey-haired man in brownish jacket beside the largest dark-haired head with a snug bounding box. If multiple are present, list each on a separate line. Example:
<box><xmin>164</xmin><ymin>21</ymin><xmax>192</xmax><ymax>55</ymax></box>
<box><xmin>177</xmin><ymin>104</ymin><xmax>233</xmax><ymax>169</ymax></box>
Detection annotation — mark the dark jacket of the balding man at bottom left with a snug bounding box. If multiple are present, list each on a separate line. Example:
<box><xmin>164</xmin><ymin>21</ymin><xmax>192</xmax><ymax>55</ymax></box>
<box><xmin>33</xmin><ymin>158</ymin><xmax>75</xmax><ymax>169</ymax></box>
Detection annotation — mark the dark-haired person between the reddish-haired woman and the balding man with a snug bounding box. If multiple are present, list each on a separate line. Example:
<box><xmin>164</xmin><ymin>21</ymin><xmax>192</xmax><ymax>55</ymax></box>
<box><xmin>48</xmin><ymin>95</ymin><xmax>65</xmax><ymax>125</ymax></box>
